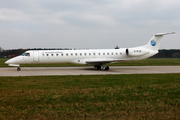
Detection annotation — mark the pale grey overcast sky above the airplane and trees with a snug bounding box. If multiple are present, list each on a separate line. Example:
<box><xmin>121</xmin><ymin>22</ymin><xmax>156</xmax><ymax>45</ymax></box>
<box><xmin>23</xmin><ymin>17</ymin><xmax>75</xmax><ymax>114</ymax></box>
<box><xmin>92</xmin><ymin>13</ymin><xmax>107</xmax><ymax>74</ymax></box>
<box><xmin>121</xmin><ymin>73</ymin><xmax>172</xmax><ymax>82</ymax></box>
<box><xmin>0</xmin><ymin>0</ymin><xmax>180</xmax><ymax>49</ymax></box>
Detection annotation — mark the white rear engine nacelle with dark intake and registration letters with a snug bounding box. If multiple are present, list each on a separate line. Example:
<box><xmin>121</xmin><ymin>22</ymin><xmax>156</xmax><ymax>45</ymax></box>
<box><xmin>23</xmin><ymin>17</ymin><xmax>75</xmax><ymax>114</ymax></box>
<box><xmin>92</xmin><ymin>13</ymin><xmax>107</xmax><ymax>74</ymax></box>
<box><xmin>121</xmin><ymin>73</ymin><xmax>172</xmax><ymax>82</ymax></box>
<box><xmin>126</xmin><ymin>48</ymin><xmax>150</xmax><ymax>57</ymax></box>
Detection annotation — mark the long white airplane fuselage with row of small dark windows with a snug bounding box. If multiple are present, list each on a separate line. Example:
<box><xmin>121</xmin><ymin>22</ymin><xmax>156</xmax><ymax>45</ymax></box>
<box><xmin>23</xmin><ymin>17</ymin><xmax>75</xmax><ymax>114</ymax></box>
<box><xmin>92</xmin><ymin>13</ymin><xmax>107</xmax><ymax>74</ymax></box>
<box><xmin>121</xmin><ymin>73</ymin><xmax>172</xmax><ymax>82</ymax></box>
<box><xmin>6</xmin><ymin>49</ymin><xmax>157</xmax><ymax>66</ymax></box>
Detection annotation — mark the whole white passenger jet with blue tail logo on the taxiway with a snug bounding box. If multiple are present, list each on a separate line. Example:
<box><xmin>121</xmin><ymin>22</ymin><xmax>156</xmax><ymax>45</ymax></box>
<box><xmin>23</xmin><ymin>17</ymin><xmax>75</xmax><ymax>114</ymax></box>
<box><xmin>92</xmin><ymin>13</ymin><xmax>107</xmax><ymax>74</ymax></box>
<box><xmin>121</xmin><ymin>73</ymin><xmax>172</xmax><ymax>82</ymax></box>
<box><xmin>5</xmin><ymin>32</ymin><xmax>175</xmax><ymax>71</ymax></box>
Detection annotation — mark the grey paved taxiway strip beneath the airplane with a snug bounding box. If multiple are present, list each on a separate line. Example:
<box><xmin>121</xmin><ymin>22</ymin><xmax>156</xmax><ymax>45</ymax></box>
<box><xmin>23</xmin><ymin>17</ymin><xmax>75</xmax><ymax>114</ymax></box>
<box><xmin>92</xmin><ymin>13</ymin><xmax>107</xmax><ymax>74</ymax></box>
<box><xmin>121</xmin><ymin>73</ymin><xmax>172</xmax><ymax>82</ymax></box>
<box><xmin>0</xmin><ymin>66</ymin><xmax>180</xmax><ymax>76</ymax></box>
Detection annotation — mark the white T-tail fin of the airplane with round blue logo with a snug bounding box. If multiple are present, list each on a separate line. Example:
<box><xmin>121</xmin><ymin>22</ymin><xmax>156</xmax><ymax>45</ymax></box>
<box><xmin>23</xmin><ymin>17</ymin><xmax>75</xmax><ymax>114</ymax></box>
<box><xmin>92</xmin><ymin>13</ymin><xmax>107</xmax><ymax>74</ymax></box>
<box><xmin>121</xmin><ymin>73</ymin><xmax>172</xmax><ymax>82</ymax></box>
<box><xmin>143</xmin><ymin>32</ymin><xmax>175</xmax><ymax>51</ymax></box>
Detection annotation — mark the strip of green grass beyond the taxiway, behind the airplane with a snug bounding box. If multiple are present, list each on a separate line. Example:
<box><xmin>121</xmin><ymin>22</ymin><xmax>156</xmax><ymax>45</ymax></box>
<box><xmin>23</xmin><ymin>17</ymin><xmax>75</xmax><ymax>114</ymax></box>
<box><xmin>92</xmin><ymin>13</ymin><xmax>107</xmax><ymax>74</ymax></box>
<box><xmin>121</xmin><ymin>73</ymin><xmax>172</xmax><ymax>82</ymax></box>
<box><xmin>0</xmin><ymin>58</ymin><xmax>180</xmax><ymax>67</ymax></box>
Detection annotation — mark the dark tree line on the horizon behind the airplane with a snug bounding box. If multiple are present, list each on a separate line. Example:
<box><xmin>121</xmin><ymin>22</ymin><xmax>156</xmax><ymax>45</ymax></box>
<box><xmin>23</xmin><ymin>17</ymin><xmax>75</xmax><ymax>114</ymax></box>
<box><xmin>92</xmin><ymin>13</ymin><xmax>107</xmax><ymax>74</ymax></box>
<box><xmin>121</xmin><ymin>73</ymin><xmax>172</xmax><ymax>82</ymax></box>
<box><xmin>0</xmin><ymin>47</ymin><xmax>180</xmax><ymax>58</ymax></box>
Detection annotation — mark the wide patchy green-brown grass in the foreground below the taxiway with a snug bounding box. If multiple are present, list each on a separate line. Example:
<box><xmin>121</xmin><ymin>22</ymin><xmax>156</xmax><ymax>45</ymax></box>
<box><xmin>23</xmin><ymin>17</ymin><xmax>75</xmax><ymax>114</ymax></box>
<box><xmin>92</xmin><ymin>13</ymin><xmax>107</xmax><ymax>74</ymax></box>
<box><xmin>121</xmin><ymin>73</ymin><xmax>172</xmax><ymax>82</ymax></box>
<box><xmin>0</xmin><ymin>74</ymin><xmax>180</xmax><ymax>120</ymax></box>
